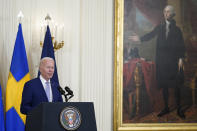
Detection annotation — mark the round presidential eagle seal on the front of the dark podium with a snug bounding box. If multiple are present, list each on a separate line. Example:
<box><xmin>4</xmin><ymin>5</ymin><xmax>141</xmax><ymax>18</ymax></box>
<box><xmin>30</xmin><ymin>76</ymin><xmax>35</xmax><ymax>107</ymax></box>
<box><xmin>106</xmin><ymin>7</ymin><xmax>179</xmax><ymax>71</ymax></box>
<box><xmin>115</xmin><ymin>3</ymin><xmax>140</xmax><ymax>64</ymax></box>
<box><xmin>60</xmin><ymin>106</ymin><xmax>81</xmax><ymax>131</ymax></box>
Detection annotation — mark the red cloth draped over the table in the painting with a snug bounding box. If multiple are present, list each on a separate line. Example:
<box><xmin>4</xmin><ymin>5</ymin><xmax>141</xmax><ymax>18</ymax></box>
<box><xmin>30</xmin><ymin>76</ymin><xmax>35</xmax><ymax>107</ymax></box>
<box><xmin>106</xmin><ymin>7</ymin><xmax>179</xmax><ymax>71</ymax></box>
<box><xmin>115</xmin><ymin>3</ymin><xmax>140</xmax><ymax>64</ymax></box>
<box><xmin>123</xmin><ymin>58</ymin><xmax>157</xmax><ymax>112</ymax></box>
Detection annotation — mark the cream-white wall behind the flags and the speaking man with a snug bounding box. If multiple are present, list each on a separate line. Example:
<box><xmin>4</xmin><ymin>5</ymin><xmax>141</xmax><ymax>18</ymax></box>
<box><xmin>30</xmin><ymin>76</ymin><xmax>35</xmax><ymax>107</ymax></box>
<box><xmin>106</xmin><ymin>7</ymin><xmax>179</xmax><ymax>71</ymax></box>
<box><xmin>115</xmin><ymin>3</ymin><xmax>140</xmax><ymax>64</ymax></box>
<box><xmin>0</xmin><ymin>0</ymin><xmax>113</xmax><ymax>131</ymax></box>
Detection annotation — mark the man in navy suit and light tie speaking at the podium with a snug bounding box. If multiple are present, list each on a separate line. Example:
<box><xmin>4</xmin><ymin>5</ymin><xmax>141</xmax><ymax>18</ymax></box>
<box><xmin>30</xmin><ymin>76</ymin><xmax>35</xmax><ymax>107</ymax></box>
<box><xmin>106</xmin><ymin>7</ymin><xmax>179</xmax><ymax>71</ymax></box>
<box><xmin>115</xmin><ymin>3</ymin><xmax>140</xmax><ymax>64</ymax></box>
<box><xmin>21</xmin><ymin>57</ymin><xmax>63</xmax><ymax>114</ymax></box>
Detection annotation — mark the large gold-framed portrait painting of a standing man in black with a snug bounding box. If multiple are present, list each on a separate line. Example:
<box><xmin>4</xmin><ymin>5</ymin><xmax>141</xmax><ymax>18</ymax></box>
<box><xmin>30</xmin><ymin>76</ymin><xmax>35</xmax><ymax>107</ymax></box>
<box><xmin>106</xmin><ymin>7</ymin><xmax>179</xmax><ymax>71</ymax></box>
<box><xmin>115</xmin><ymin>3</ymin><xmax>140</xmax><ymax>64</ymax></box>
<box><xmin>114</xmin><ymin>0</ymin><xmax>197</xmax><ymax>131</ymax></box>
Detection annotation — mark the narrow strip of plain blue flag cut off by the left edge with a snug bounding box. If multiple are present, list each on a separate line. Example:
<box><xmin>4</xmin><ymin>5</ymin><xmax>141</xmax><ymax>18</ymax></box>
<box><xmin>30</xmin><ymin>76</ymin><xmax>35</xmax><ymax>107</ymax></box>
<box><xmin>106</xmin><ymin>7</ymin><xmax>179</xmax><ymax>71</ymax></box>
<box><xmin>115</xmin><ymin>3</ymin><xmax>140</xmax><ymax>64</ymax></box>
<box><xmin>0</xmin><ymin>85</ymin><xmax>5</xmax><ymax>131</ymax></box>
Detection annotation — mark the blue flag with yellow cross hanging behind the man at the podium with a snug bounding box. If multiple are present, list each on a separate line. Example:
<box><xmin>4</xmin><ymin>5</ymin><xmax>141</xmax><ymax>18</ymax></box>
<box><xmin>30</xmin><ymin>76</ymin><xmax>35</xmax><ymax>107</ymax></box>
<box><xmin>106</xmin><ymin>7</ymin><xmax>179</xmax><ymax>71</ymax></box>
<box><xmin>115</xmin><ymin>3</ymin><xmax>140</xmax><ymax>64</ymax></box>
<box><xmin>6</xmin><ymin>24</ymin><xmax>30</xmax><ymax>131</ymax></box>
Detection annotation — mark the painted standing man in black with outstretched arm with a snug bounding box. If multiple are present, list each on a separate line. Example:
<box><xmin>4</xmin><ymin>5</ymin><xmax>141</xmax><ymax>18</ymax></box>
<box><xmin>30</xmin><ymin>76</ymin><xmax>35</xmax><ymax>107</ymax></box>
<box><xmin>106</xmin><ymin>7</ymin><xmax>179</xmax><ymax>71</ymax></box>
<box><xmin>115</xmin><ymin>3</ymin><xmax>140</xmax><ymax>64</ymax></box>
<box><xmin>129</xmin><ymin>5</ymin><xmax>185</xmax><ymax>118</ymax></box>
